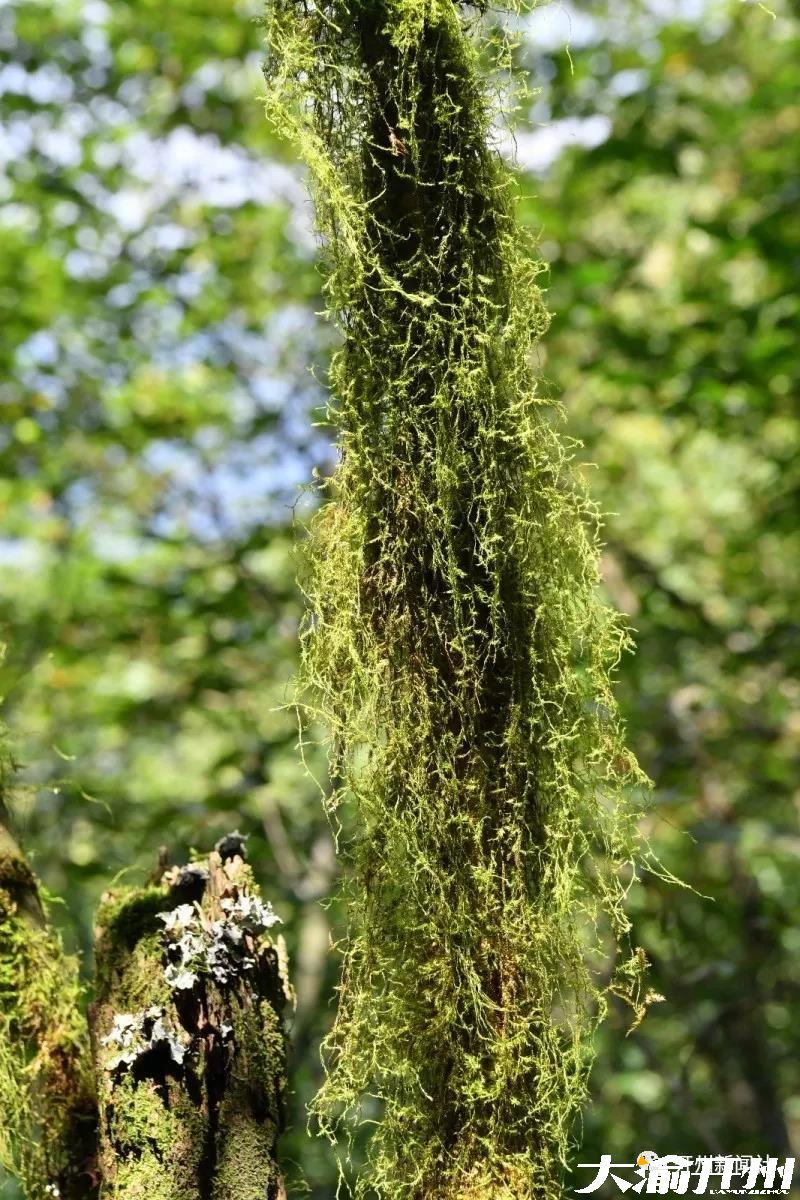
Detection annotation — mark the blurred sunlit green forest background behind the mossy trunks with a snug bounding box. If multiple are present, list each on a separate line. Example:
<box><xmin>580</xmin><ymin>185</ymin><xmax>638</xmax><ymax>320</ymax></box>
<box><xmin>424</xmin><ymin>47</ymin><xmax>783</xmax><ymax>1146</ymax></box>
<box><xmin>0</xmin><ymin>0</ymin><xmax>800</xmax><ymax>1200</ymax></box>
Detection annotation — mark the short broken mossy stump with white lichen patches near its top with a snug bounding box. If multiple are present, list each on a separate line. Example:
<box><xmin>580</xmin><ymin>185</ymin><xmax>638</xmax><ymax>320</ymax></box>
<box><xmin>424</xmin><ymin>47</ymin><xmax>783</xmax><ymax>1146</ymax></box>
<box><xmin>91</xmin><ymin>835</ymin><xmax>290</xmax><ymax>1200</ymax></box>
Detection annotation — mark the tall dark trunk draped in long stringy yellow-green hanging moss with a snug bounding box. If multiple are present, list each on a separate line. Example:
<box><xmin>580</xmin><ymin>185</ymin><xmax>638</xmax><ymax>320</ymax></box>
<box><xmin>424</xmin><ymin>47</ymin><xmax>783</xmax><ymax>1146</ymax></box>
<box><xmin>266</xmin><ymin>0</ymin><xmax>644</xmax><ymax>1200</ymax></box>
